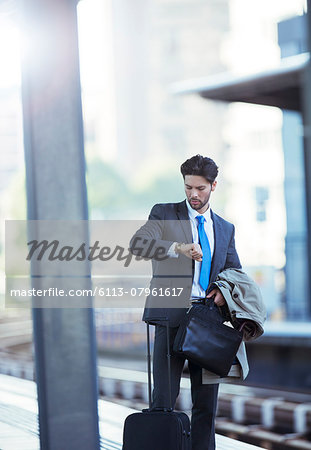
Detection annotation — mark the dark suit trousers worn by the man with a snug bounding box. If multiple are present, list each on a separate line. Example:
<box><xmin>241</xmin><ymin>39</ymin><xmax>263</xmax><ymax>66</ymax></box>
<box><xmin>152</xmin><ymin>325</ymin><xmax>219</xmax><ymax>450</ymax></box>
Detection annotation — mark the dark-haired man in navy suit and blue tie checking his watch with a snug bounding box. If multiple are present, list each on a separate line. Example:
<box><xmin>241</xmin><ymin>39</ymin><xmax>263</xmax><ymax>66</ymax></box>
<box><xmin>130</xmin><ymin>155</ymin><xmax>241</xmax><ymax>450</ymax></box>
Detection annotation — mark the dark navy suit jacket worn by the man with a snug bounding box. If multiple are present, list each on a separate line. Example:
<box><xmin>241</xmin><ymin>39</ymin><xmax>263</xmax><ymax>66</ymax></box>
<box><xmin>130</xmin><ymin>201</ymin><xmax>241</xmax><ymax>327</ymax></box>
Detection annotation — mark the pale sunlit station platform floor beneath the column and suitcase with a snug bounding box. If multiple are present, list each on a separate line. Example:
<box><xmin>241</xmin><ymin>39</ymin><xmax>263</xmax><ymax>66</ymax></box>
<box><xmin>0</xmin><ymin>374</ymin><xmax>260</xmax><ymax>450</ymax></box>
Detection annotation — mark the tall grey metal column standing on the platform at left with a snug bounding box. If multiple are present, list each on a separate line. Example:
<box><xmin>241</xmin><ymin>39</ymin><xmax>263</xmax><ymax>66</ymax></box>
<box><xmin>22</xmin><ymin>0</ymin><xmax>99</xmax><ymax>450</ymax></box>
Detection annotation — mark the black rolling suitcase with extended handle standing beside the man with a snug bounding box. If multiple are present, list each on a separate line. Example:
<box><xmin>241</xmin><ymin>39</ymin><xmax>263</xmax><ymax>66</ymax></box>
<box><xmin>122</xmin><ymin>319</ymin><xmax>191</xmax><ymax>450</ymax></box>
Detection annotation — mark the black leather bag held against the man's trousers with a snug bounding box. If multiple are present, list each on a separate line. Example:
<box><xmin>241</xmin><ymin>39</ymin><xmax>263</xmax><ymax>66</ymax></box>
<box><xmin>174</xmin><ymin>299</ymin><xmax>243</xmax><ymax>377</ymax></box>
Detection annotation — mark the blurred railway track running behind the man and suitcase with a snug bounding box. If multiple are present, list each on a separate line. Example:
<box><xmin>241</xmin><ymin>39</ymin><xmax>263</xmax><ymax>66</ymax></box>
<box><xmin>0</xmin><ymin>358</ymin><xmax>311</xmax><ymax>450</ymax></box>
